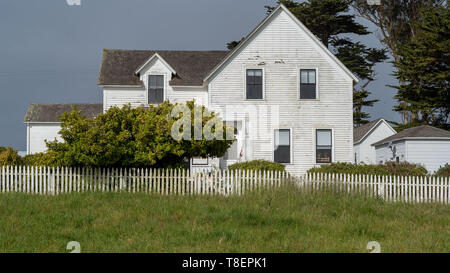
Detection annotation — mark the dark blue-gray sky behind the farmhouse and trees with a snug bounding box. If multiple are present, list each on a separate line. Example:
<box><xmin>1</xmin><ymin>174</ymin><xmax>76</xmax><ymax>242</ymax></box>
<box><xmin>0</xmin><ymin>0</ymin><xmax>400</xmax><ymax>150</ymax></box>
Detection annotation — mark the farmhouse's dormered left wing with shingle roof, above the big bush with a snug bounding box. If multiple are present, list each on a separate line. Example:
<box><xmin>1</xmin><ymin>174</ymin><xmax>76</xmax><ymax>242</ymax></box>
<box><xmin>99</xmin><ymin>50</ymin><xmax>226</xmax><ymax>110</ymax></box>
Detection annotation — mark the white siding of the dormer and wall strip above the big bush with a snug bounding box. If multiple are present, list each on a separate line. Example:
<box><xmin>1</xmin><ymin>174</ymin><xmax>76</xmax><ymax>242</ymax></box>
<box><xmin>103</xmin><ymin>58</ymin><xmax>208</xmax><ymax>110</ymax></box>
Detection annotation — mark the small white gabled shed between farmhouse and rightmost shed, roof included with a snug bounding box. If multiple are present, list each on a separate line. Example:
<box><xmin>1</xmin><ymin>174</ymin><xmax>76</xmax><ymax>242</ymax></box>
<box><xmin>353</xmin><ymin>118</ymin><xmax>397</xmax><ymax>164</ymax></box>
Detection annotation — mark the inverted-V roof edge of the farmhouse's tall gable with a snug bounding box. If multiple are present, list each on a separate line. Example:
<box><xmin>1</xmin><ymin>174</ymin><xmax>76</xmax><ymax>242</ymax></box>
<box><xmin>205</xmin><ymin>4</ymin><xmax>359</xmax><ymax>83</ymax></box>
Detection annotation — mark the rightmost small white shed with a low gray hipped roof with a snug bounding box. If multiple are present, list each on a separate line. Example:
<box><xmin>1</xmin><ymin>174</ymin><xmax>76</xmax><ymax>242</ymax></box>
<box><xmin>373</xmin><ymin>125</ymin><xmax>450</xmax><ymax>174</ymax></box>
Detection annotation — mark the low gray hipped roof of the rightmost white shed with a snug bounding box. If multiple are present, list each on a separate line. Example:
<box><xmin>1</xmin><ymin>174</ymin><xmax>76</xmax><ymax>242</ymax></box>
<box><xmin>372</xmin><ymin>125</ymin><xmax>450</xmax><ymax>146</ymax></box>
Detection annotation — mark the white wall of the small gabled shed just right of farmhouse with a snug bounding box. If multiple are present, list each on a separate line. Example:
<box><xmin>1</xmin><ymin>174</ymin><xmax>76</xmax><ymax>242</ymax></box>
<box><xmin>355</xmin><ymin>121</ymin><xmax>396</xmax><ymax>164</ymax></box>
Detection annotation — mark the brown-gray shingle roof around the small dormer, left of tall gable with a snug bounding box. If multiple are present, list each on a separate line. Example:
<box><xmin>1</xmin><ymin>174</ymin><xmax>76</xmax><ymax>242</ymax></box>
<box><xmin>98</xmin><ymin>49</ymin><xmax>229</xmax><ymax>86</ymax></box>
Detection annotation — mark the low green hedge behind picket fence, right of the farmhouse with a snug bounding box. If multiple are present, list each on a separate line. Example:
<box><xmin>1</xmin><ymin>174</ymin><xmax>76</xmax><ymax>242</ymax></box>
<box><xmin>308</xmin><ymin>162</ymin><xmax>428</xmax><ymax>176</ymax></box>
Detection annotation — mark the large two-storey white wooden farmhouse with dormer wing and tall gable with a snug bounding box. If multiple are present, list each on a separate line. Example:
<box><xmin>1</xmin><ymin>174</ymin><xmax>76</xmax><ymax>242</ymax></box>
<box><xmin>26</xmin><ymin>5</ymin><xmax>358</xmax><ymax>174</ymax></box>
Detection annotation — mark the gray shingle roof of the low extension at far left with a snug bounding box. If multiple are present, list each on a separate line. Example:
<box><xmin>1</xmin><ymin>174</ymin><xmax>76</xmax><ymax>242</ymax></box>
<box><xmin>24</xmin><ymin>103</ymin><xmax>103</xmax><ymax>122</ymax></box>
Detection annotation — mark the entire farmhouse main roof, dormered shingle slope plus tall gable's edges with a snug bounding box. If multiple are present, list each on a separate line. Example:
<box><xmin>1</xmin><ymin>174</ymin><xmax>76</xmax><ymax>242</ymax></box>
<box><xmin>98</xmin><ymin>4</ymin><xmax>358</xmax><ymax>86</ymax></box>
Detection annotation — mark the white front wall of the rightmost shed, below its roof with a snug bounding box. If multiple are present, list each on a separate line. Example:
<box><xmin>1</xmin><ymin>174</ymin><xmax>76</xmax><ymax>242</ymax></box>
<box><xmin>406</xmin><ymin>140</ymin><xmax>450</xmax><ymax>173</ymax></box>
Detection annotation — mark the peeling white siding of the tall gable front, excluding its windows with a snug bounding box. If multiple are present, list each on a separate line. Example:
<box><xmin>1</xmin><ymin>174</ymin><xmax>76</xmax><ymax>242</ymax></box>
<box><xmin>209</xmin><ymin>12</ymin><xmax>353</xmax><ymax>174</ymax></box>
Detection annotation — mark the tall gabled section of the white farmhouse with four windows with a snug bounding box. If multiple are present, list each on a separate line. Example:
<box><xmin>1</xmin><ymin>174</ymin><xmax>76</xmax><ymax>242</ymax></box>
<box><xmin>207</xmin><ymin>7</ymin><xmax>356</xmax><ymax>174</ymax></box>
